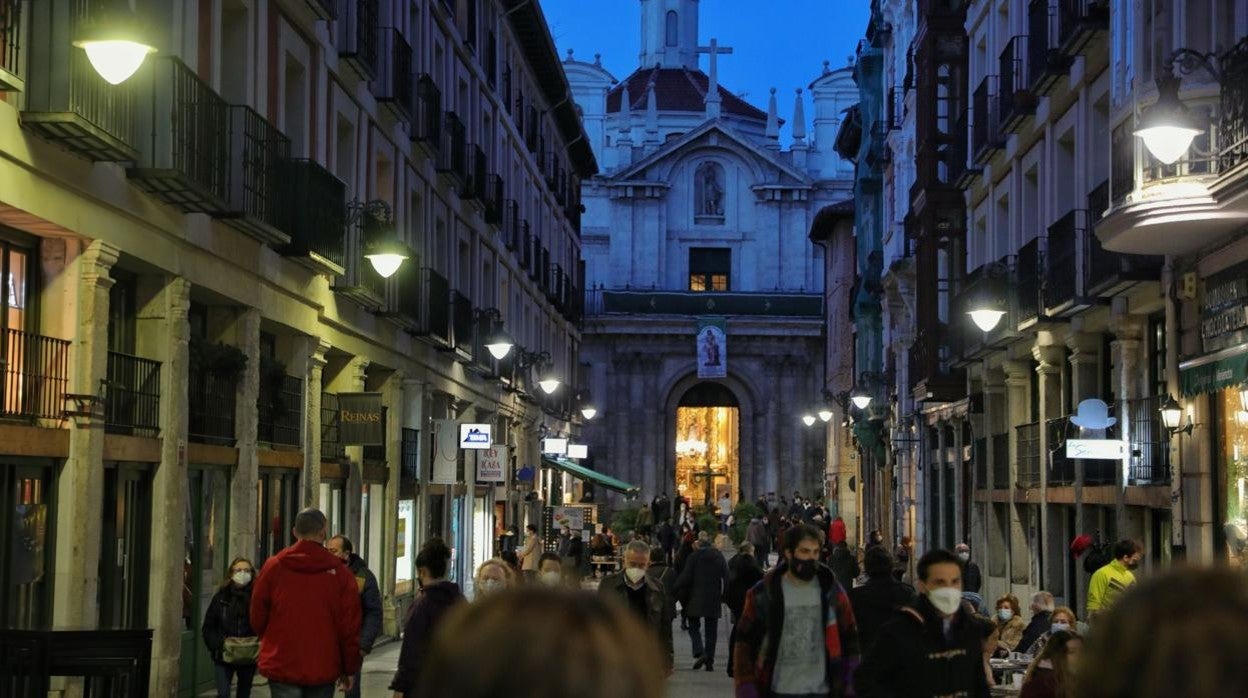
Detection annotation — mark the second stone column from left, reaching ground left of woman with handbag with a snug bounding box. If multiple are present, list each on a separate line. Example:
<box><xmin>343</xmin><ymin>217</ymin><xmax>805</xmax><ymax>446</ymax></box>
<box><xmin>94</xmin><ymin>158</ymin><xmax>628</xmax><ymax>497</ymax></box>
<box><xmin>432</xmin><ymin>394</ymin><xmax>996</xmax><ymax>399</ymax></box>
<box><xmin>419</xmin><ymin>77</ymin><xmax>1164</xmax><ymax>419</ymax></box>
<box><xmin>139</xmin><ymin>278</ymin><xmax>189</xmax><ymax>696</ymax></box>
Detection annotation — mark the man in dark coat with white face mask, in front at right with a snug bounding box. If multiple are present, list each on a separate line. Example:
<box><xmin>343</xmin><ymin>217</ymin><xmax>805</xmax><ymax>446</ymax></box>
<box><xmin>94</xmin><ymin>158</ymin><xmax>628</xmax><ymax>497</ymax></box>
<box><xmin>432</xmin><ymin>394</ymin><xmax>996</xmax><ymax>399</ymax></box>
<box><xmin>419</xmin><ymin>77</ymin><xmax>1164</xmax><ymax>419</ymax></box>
<box><xmin>854</xmin><ymin>549</ymin><xmax>990</xmax><ymax>698</ymax></box>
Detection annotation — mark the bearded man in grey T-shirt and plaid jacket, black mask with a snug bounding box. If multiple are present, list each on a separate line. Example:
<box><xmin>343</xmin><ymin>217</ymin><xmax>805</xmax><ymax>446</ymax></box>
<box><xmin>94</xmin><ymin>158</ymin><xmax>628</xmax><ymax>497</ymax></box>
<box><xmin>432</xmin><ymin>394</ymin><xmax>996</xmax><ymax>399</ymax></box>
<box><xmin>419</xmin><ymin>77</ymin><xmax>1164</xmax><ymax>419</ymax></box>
<box><xmin>733</xmin><ymin>523</ymin><xmax>860</xmax><ymax>698</ymax></box>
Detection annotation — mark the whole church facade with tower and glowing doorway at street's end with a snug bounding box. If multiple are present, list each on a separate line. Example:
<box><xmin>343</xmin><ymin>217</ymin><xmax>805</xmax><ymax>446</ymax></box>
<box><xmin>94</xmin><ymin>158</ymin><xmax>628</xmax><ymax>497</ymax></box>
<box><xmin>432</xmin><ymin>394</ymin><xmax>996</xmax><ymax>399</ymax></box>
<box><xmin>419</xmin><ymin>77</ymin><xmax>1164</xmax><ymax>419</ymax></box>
<box><xmin>564</xmin><ymin>0</ymin><xmax>857</xmax><ymax>514</ymax></box>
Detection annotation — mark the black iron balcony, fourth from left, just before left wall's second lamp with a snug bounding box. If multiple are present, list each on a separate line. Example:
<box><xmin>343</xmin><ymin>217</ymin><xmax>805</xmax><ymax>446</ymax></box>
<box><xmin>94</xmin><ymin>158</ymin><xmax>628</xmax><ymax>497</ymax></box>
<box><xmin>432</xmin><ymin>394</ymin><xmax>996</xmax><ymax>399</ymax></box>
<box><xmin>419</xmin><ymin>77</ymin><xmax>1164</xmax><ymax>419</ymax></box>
<box><xmin>277</xmin><ymin>160</ymin><xmax>347</xmax><ymax>273</ymax></box>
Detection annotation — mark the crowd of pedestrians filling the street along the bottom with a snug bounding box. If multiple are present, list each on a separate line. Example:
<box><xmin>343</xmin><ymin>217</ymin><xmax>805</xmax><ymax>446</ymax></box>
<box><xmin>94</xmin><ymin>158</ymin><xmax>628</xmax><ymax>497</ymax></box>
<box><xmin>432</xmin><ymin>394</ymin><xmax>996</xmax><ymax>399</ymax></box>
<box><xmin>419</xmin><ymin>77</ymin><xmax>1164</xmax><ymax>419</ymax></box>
<box><xmin>202</xmin><ymin>496</ymin><xmax>1248</xmax><ymax>698</ymax></box>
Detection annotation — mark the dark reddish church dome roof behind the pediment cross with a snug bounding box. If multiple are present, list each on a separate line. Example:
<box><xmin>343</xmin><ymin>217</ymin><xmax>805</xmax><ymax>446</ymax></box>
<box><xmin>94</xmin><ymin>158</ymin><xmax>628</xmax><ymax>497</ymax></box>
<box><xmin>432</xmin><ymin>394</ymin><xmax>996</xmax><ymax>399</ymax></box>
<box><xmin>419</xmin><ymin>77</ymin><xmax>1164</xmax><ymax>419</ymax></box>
<box><xmin>607</xmin><ymin>66</ymin><xmax>768</xmax><ymax>122</ymax></box>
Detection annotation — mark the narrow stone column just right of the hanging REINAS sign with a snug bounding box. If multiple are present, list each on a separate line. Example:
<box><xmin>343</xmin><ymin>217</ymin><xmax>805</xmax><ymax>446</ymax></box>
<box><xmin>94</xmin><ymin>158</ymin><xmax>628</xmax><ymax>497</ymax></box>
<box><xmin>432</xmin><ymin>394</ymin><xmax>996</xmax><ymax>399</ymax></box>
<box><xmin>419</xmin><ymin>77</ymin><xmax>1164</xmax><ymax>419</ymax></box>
<box><xmin>376</xmin><ymin>371</ymin><xmax>406</xmax><ymax>637</ymax></box>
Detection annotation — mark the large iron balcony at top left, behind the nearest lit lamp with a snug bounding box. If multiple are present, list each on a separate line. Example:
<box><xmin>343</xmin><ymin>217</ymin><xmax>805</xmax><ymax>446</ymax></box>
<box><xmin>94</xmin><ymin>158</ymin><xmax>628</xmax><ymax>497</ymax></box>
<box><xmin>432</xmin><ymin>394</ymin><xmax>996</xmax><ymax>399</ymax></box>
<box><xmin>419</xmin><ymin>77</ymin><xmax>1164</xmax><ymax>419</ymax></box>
<box><xmin>21</xmin><ymin>0</ymin><xmax>141</xmax><ymax>162</ymax></box>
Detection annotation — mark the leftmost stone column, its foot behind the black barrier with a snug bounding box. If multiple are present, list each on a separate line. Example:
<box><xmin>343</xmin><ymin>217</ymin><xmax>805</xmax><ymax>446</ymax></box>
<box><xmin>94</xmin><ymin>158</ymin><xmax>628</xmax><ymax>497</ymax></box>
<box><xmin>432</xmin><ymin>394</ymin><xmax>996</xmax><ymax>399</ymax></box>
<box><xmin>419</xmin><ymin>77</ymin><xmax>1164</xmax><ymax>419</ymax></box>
<box><xmin>53</xmin><ymin>240</ymin><xmax>120</xmax><ymax>628</ymax></box>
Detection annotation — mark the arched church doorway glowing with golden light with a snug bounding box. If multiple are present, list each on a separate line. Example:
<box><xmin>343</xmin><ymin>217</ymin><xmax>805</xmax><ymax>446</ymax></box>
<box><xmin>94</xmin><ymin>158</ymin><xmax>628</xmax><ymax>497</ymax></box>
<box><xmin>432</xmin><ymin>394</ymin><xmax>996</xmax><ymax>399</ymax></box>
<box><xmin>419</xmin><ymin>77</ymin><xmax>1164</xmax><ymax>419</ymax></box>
<box><xmin>675</xmin><ymin>382</ymin><xmax>741</xmax><ymax>506</ymax></box>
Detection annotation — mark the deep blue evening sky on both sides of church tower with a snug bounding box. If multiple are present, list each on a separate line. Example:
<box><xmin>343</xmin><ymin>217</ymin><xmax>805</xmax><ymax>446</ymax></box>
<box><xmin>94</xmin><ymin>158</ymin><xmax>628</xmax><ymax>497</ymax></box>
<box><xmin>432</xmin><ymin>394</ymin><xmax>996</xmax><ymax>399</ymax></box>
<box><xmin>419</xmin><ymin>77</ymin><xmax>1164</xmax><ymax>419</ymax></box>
<box><xmin>540</xmin><ymin>0</ymin><xmax>870</xmax><ymax>141</ymax></box>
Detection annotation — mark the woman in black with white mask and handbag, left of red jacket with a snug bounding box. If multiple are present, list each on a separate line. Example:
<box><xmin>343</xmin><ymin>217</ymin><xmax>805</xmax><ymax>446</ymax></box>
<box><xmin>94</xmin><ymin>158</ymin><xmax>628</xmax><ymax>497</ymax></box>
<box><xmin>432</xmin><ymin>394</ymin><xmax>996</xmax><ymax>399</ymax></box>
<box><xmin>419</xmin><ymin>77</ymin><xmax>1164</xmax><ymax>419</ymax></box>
<box><xmin>201</xmin><ymin>557</ymin><xmax>258</xmax><ymax>698</ymax></box>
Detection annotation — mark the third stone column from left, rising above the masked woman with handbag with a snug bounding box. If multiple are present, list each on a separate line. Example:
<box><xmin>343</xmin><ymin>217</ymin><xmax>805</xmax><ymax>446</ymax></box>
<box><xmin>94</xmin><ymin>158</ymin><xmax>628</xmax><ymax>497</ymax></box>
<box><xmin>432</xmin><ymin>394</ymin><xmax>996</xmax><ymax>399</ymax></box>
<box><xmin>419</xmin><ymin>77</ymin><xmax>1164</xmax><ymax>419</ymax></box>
<box><xmin>230</xmin><ymin>308</ymin><xmax>260</xmax><ymax>558</ymax></box>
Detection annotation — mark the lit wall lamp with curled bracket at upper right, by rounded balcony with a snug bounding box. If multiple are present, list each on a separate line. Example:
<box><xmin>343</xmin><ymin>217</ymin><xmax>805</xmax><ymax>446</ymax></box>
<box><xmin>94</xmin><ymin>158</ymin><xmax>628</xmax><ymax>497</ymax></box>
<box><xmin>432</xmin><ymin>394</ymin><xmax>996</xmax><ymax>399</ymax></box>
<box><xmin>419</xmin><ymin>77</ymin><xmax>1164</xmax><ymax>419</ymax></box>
<box><xmin>1134</xmin><ymin>49</ymin><xmax>1222</xmax><ymax>165</ymax></box>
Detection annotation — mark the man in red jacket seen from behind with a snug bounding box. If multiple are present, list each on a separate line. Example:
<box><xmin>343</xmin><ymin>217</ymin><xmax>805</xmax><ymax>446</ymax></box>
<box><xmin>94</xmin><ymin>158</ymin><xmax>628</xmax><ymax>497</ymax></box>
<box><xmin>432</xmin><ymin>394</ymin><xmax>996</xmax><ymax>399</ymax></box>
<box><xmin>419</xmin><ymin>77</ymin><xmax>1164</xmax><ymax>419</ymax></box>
<box><xmin>251</xmin><ymin>509</ymin><xmax>363</xmax><ymax>698</ymax></box>
